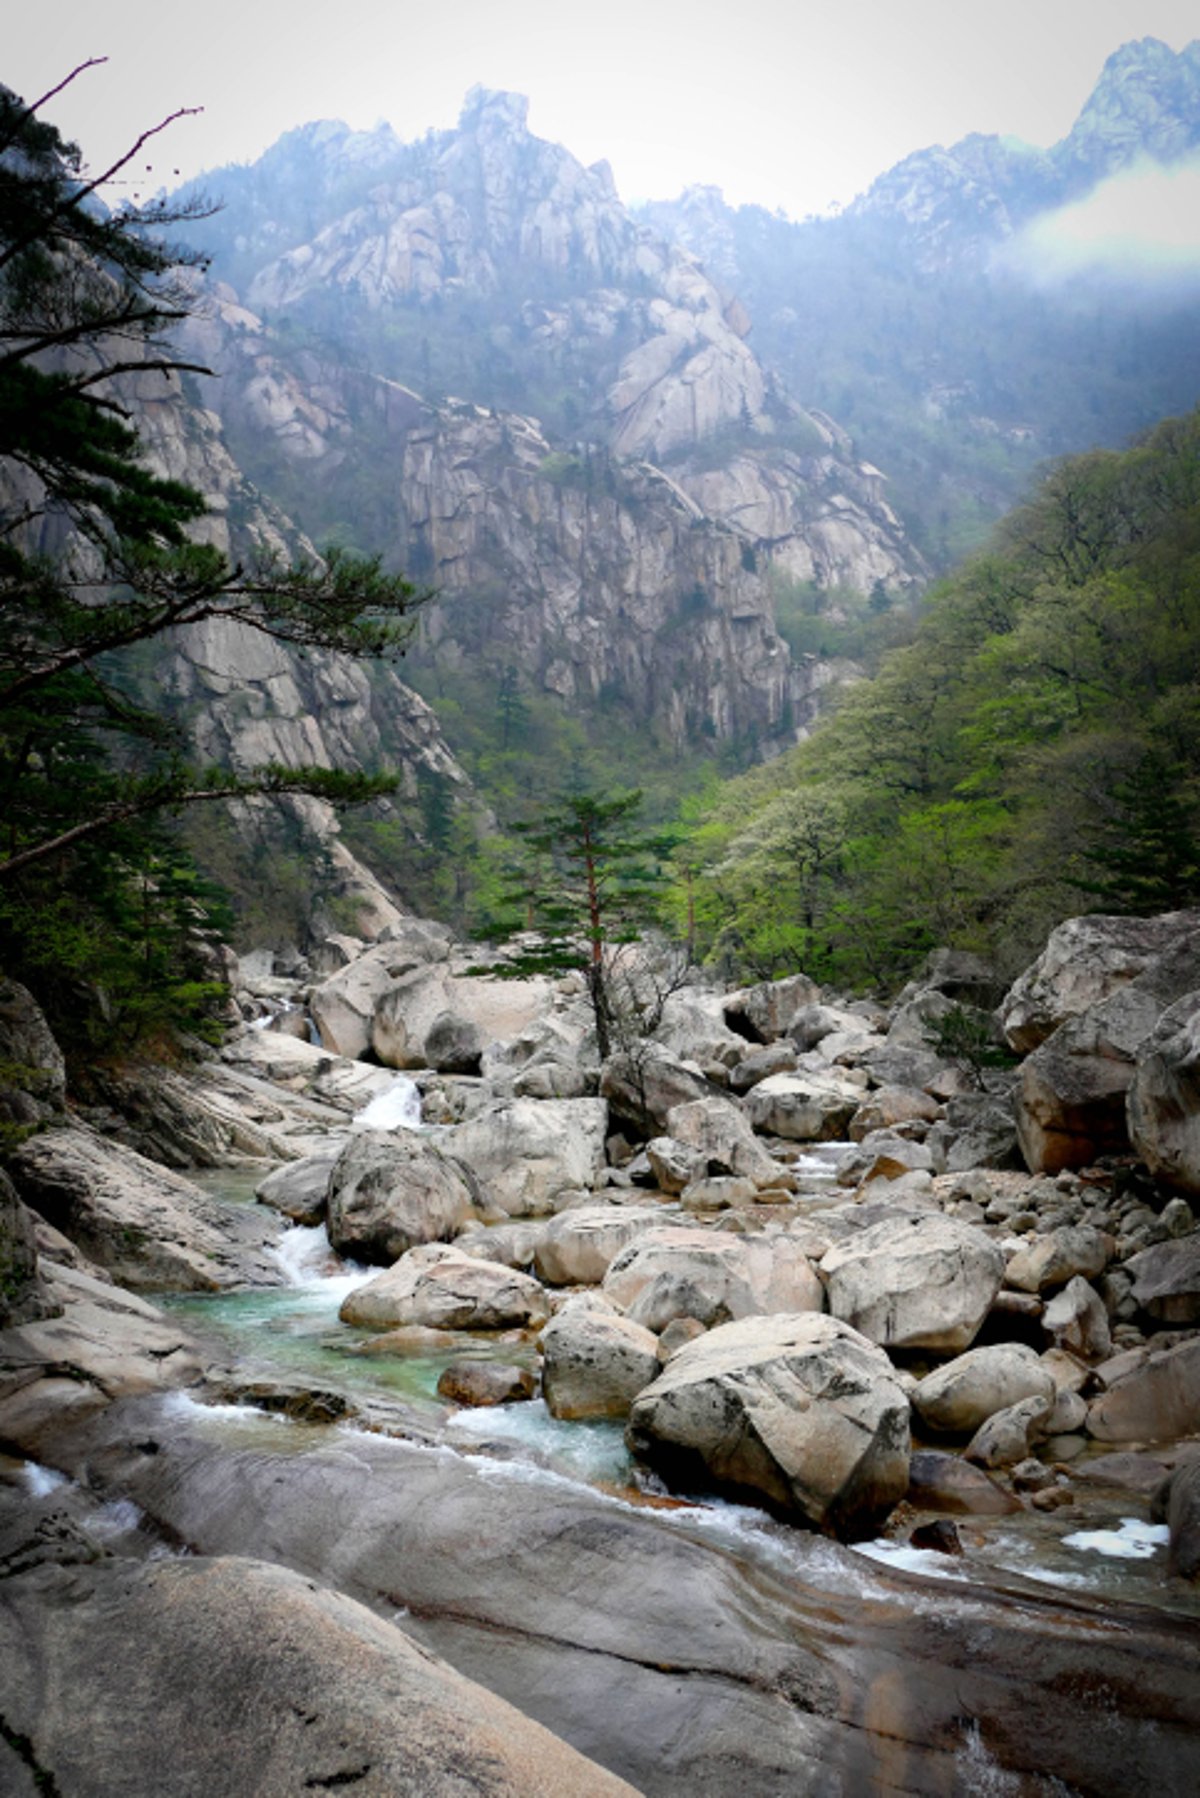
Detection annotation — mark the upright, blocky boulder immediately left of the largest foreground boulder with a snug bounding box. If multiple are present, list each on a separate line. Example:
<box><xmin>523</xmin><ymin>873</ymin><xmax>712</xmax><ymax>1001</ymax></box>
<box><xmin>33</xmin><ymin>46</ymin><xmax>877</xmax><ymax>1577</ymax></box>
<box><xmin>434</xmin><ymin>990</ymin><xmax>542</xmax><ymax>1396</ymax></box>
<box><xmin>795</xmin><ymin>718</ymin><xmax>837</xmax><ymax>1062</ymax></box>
<box><xmin>542</xmin><ymin>1293</ymin><xmax>658</xmax><ymax>1419</ymax></box>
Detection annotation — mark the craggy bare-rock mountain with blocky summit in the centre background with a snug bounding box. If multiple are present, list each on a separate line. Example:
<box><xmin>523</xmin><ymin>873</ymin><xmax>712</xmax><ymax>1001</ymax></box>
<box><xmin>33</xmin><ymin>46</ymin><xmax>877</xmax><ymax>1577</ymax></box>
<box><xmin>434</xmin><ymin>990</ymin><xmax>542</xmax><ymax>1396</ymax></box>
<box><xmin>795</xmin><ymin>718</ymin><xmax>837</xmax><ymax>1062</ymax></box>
<box><xmin>166</xmin><ymin>88</ymin><xmax>927</xmax><ymax>780</ymax></box>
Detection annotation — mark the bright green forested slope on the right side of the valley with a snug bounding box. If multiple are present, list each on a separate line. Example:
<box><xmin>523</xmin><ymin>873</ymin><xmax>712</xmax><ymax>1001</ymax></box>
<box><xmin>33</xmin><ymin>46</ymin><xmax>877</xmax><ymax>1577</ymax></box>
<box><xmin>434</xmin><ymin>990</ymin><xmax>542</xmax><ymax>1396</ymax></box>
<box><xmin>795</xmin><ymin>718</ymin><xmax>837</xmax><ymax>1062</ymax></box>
<box><xmin>675</xmin><ymin>414</ymin><xmax>1200</xmax><ymax>987</ymax></box>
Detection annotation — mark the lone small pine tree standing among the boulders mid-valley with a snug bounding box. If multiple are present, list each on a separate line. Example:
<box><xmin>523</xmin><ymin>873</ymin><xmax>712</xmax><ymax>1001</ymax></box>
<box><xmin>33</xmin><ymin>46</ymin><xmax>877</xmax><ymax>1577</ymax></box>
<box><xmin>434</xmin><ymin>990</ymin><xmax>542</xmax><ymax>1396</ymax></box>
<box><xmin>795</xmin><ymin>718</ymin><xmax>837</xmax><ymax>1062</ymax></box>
<box><xmin>489</xmin><ymin>791</ymin><xmax>676</xmax><ymax>1059</ymax></box>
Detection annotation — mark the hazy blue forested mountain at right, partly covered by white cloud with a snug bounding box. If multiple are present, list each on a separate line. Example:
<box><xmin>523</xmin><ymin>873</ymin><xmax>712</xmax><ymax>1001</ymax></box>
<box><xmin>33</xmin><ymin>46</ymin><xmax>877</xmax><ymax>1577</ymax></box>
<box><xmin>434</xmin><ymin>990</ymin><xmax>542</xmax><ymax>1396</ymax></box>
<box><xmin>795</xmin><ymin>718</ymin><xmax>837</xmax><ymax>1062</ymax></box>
<box><xmin>642</xmin><ymin>38</ymin><xmax>1200</xmax><ymax>568</ymax></box>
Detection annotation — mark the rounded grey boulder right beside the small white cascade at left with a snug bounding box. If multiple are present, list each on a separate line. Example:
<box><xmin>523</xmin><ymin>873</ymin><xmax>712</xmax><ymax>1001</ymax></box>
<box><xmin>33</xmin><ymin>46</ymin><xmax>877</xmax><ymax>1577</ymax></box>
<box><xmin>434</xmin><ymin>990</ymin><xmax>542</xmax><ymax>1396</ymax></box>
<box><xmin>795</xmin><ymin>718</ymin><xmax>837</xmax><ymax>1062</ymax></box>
<box><xmin>326</xmin><ymin>1129</ymin><xmax>475</xmax><ymax>1264</ymax></box>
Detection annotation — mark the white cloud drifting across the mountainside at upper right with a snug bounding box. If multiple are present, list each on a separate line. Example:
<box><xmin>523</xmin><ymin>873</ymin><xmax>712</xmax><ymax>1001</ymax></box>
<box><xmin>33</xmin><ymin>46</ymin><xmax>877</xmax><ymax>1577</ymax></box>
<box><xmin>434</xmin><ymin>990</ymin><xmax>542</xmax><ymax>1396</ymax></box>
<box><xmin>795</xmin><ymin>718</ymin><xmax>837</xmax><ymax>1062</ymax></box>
<box><xmin>997</xmin><ymin>160</ymin><xmax>1200</xmax><ymax>293</ymax></box>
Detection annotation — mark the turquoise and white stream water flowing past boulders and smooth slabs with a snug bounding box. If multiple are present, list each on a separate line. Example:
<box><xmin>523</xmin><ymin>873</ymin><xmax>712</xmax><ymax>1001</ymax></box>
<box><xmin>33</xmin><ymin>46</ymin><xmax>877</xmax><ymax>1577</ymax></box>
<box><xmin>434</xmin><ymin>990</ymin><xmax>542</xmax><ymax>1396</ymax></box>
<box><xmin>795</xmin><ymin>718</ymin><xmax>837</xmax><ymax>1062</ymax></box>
<box><xmin>166</xmin><ymin>1150</ymin><xmax>1200</xmax><ymax>1618</ymax></box>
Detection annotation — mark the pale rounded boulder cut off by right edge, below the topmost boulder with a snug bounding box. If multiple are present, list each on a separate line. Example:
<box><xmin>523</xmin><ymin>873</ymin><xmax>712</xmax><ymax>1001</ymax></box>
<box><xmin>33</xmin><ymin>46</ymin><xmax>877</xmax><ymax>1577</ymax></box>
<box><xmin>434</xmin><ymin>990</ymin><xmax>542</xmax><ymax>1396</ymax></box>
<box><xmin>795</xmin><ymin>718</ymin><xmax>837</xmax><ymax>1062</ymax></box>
<box><xmin>1128</xmin><ymin>992</ymin><xmax>1200</xmax><ymax>1194</ymax></box>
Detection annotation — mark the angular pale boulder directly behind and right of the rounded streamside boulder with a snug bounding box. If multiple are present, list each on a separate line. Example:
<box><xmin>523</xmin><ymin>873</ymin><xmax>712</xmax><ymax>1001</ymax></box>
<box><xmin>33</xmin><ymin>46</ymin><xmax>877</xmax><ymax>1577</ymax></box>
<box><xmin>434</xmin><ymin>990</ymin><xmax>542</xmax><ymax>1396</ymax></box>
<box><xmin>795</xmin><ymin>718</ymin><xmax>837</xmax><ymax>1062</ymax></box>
<box><xmin>444</xmin><ymin>1099</ymin><xmax>608</xmax><ymax>1217</ymax></box>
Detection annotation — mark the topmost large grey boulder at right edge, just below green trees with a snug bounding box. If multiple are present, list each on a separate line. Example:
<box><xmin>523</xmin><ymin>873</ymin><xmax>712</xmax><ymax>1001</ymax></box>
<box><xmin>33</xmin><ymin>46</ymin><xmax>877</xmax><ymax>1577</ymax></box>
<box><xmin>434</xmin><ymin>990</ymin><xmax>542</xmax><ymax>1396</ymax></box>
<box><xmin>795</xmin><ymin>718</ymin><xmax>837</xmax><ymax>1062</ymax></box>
<box><xmin>999</xmin><ymin>912</ymin><xmax>1200</xmax><ymax>1055</ymax></box>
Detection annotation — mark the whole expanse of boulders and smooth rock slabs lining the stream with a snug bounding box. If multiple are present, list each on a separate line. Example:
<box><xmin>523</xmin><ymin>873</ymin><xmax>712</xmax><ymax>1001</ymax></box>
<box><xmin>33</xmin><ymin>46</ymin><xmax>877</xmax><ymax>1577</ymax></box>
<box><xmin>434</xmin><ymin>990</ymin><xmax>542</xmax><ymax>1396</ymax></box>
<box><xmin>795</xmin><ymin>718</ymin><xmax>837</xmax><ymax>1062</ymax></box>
<box><xmin>0</xmin><ymin>913</ymin><xmax>1200</xmax><ymax>1794</ymax></box>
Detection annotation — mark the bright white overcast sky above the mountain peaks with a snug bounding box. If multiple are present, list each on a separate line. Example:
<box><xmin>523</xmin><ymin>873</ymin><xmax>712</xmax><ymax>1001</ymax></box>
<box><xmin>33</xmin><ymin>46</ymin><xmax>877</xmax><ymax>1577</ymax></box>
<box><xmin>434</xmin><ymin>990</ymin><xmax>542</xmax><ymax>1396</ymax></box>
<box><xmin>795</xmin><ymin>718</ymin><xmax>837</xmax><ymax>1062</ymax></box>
<box><xmin>0</xmin><ymin>0</ymin><xmax>1200</xmax><ymax>218</ymax></box>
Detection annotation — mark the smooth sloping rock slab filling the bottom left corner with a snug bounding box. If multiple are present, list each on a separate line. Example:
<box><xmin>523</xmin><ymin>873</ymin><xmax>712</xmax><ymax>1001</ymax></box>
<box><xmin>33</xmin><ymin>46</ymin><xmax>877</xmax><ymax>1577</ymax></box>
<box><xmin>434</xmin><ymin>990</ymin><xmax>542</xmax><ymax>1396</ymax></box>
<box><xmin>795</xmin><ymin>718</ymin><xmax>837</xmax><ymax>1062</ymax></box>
<box><xmin>0</xmin><ymin>1557</ymin><xmax>633</xmax><ymax>1798</ymax></box>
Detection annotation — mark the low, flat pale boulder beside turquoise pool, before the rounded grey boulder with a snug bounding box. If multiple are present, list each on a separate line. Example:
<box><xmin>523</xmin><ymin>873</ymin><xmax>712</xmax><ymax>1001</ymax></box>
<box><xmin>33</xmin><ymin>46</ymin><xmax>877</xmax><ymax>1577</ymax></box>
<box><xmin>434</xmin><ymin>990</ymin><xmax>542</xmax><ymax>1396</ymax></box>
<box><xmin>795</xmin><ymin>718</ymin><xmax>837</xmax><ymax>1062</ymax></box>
<box><xmin>338</xmin><ymin>1242</ymin><xmax>551</xmax><ymax>1331</ymax></box>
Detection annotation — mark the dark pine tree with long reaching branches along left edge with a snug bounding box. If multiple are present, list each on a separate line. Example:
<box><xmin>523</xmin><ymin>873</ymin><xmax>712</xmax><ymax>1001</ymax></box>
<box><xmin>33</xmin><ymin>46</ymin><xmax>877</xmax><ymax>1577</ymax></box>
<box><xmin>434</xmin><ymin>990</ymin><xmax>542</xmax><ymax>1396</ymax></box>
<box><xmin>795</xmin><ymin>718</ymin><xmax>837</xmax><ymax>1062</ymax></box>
<box><xmin>0</xmin><ymin>63</ymin><xmax>425</xmax><ymax>1050</ymax></box>
